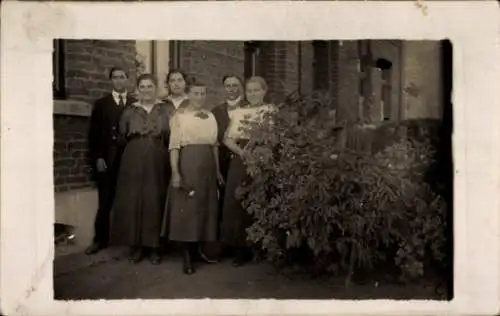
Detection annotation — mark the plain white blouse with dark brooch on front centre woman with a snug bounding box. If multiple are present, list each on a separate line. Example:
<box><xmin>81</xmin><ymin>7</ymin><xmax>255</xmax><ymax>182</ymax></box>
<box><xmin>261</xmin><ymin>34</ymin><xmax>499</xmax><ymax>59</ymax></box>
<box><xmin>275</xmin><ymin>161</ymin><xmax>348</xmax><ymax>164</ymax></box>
<box><xmin>169</xmin><ymin>109</ymin><xmax>217</xmax><ymax>149</ymax></box>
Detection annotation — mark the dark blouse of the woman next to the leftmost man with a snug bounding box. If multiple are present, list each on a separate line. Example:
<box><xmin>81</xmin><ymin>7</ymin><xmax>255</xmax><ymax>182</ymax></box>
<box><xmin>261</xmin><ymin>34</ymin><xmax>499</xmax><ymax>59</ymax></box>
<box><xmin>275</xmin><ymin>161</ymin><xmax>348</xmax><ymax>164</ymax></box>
<box><xmin>120</xmin><ymin>103</ymin><xmax>174</xmax><ymax>144</ymax></box>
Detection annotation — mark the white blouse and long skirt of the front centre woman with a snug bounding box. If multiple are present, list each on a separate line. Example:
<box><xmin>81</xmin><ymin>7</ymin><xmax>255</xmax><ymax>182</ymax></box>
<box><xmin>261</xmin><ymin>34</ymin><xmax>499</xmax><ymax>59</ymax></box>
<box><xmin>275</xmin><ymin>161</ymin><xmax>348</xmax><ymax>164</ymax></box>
<box><xmin>165</xmin><ymin>109</ymin><xmax>219</xmax><ymax>242</ymax></box>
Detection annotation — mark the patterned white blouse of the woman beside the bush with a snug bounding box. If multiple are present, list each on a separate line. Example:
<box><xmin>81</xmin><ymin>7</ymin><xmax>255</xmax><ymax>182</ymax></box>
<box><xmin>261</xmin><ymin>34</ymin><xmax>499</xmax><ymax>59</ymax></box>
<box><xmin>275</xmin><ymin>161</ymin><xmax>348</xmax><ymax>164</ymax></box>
<box><xmin>224</xmin><ymin>104</ymin><xmax>275</xmax><ymax>139</ymax></box>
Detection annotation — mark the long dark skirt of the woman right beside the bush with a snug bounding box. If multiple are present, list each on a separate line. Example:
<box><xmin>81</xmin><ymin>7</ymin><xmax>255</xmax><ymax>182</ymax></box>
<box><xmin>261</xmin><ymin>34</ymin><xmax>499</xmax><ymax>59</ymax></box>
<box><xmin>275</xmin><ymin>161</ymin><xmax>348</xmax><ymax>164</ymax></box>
<box><xmin>221</xmin><ymin>142</ymin><xmax>253</xmax><ymax>247</ymax></box>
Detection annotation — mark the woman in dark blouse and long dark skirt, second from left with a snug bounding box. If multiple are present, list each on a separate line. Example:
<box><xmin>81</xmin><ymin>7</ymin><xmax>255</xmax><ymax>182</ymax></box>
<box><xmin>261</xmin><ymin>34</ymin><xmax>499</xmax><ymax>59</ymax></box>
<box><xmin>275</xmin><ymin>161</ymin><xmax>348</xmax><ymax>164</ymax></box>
<box><xmin>111</xmin><ymin>75</ymin><xmax>173</xmax><ymax>264</ymax></box>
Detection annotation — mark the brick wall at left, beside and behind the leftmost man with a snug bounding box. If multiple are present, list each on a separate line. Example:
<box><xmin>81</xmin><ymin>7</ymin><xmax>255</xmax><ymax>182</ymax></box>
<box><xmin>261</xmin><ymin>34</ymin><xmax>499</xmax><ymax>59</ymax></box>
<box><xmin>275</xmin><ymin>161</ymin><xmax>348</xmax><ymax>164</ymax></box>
<box><xmin>54</xmin><ymin>40</ymin><xmax>135</xmax><ymax>192</ymax></box>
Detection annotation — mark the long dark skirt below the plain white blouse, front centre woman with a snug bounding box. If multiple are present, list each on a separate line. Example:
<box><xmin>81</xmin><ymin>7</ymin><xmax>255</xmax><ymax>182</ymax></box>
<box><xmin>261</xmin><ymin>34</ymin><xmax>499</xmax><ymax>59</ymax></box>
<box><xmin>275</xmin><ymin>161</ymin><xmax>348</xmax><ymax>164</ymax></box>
<box><xmin>166</xmin><ymin>145</ymin><xmax>219</xmax><ymax>242</ymax></box>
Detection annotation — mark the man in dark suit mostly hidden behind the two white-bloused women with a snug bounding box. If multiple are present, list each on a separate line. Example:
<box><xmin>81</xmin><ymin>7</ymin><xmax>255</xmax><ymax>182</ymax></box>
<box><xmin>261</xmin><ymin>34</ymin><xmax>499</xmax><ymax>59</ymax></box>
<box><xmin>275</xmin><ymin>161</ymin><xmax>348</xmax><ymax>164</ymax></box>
<box><xmin>201</xmin><ymin>75</ymin><xmax>244</xmax><ymax>261</ymax></box>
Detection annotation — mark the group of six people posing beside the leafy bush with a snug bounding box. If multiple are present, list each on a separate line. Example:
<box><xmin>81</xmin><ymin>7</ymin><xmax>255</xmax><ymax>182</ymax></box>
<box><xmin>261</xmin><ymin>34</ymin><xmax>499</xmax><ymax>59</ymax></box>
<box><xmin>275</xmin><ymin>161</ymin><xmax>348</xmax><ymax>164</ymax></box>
<box><xmin>86</xmin><ymin>68</ymin><xmax>275</xmax><ymax>274</ymax></box>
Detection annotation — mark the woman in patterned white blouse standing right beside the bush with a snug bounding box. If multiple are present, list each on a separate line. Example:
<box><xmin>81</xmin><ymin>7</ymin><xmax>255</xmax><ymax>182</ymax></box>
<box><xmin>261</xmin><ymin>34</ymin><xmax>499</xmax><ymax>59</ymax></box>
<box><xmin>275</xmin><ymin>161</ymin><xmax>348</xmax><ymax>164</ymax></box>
<box><xmin>222</xmin><ymin>77</ymin><xmax>275</xmax><ymax>266</ymax></box>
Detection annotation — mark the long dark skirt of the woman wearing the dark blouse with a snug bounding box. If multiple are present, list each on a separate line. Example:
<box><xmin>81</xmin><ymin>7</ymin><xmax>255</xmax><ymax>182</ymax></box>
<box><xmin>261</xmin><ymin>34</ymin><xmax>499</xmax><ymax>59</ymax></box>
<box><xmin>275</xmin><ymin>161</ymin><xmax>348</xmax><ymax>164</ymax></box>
<box><xmin>111</xmin><ymin>137</ymin><xmax>169</xmax><ymax>247</ymax></box>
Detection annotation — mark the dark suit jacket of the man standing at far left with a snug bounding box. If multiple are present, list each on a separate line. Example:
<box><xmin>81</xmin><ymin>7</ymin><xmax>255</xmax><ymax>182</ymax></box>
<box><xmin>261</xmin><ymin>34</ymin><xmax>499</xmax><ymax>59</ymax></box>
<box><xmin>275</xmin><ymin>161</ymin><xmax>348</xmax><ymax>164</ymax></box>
<box><xmin>88</xmin><ymin>93</ymin><xmax>136</xmax><ymax>175</ymax></box>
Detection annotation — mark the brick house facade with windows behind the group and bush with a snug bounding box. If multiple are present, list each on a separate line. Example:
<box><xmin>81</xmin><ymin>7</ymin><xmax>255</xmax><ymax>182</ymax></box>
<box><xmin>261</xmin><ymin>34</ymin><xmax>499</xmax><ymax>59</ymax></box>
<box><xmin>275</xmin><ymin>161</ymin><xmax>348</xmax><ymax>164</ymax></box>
<box><xmin>54</xmin><ymin>40</ymin><xmax>448</xmax><ymax>242</ymax></box>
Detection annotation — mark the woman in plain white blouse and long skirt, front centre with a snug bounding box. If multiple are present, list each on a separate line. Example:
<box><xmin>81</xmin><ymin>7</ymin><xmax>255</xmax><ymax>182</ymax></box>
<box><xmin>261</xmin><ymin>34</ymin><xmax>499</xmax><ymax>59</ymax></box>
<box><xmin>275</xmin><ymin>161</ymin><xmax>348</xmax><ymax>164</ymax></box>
<box><xmin>167</xmin><ymin>84</ymin><xmax>222</xmax><ymax>274</ymax></box>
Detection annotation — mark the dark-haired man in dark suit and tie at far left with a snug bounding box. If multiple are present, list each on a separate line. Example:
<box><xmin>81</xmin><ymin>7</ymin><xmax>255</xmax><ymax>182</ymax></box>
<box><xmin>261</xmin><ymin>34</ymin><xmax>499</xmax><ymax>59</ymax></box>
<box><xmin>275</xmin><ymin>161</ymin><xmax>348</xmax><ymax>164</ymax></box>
<box><xmin>85</xmin><ymin>67</ymin><xmax>135</xmax><ymax>255</ymax></box>
